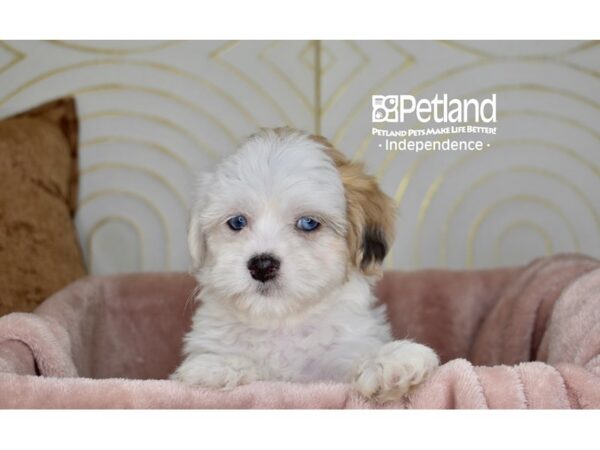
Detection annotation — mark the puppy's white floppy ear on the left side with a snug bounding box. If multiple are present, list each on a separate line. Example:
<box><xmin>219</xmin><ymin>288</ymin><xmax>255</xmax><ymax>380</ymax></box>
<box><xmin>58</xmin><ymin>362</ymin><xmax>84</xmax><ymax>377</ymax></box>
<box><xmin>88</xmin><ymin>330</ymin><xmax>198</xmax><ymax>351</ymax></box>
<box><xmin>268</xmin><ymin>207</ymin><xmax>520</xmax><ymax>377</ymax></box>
<box><xmin>188</xmin><ymin>173</ymin><xmax>212</xmax><ymax>271</ymax></box>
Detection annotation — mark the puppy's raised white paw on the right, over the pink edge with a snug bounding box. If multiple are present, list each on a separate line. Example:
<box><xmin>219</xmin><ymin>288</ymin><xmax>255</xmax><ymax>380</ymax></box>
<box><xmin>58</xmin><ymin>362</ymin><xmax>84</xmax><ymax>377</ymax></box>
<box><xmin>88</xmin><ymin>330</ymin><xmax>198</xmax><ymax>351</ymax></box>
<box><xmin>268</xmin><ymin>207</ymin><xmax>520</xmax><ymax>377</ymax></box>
<box><xmin>353</xmin><ymin>341</ymin><xmax>439</xmax><ymax>402</ymax></box>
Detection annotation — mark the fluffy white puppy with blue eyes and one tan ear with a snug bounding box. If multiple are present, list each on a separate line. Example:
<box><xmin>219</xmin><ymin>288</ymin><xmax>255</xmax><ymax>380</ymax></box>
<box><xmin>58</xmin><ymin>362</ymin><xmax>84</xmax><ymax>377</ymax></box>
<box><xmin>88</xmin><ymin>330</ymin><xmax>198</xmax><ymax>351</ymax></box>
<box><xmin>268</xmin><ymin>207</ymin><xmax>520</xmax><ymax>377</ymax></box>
<box><xmin>172</xmin><ymin>128</ymin><xmax>438</xmax><ymax>401</ymax></box>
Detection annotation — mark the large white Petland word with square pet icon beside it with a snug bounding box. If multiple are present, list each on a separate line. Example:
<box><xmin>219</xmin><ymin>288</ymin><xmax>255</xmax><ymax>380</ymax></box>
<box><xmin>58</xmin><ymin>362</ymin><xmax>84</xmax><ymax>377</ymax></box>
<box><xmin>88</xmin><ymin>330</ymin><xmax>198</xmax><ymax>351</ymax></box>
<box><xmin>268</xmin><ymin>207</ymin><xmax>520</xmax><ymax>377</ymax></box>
<box><xmin>372</xmin><ymin>94</ymin><xmax>496</xmax><ymax>123</ymax></box>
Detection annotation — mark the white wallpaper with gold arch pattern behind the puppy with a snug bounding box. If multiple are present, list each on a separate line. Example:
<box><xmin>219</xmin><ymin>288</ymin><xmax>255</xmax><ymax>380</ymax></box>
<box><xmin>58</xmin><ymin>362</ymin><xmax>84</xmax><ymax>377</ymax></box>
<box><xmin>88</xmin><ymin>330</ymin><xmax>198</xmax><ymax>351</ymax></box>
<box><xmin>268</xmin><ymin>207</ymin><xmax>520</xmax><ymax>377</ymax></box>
<box><xmin>0</xmin><ymin>41</ymin><xmax>600</xmax><ymax>274</ymax></box>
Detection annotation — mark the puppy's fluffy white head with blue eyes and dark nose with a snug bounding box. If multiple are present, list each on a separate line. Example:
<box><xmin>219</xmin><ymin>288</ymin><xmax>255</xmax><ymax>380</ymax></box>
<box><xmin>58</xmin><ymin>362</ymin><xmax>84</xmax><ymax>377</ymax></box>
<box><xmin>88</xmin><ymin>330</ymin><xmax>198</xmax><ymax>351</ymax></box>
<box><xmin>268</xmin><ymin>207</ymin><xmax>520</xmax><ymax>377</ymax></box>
<box><xmin>189</xmin><ymin>129</ymin><xmax>391</xmax><ymax>321</ymax></box>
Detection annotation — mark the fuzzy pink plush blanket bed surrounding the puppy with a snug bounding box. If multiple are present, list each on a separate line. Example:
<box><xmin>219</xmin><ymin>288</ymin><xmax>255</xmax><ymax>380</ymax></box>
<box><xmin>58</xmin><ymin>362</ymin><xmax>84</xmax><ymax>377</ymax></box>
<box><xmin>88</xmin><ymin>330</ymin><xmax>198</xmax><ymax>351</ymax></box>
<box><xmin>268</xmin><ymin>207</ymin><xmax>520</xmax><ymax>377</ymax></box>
<box><xmin>0</xmin><ymin>255</ymin><xmax>600</xmax><ymax>408</ymax></box>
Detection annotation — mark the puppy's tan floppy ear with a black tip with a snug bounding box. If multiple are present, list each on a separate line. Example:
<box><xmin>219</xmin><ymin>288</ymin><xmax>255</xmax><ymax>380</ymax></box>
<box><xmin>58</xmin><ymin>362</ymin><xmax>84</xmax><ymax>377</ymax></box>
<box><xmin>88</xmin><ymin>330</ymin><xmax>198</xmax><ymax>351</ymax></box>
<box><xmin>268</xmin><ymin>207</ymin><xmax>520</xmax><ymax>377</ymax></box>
<box><xmin>311</xmin><ymin>136</ymin><xmax>396</xmax><ymax>276</ymax></box>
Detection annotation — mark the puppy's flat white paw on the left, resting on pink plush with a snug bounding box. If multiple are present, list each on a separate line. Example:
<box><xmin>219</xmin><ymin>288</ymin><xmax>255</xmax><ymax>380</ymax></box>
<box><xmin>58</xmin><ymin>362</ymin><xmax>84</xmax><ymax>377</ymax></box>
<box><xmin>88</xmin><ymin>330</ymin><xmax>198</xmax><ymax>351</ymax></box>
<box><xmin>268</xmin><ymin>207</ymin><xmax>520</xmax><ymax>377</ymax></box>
<box><xmin>170</xmin><ymin>354</ymin><xmax>259</xmax><ymax>389</ymax></box>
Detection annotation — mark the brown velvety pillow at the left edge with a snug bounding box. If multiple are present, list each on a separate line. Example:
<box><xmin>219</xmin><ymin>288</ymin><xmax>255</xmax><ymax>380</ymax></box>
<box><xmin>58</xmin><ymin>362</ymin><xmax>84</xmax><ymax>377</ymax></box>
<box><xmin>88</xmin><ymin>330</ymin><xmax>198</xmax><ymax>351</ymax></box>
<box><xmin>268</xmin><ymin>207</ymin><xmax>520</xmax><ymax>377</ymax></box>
<box><xmin>0</xmin><ymin>98</ymin><xmax>86</xmax><ymax>315</ymax></box>
